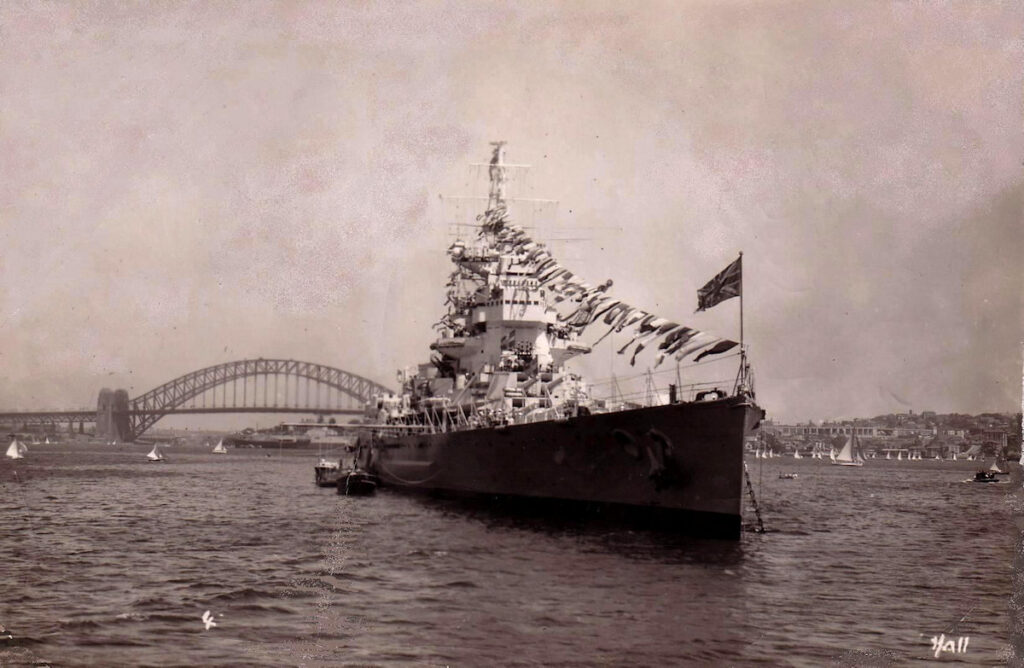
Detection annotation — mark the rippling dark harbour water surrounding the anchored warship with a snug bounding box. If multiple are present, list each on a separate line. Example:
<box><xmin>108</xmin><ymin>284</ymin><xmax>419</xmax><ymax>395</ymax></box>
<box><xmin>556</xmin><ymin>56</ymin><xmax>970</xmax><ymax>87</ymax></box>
<box><xmin>0</xmin><ymin>445</ymin><xmax>1021</xmax><ymax>666</ymax></box>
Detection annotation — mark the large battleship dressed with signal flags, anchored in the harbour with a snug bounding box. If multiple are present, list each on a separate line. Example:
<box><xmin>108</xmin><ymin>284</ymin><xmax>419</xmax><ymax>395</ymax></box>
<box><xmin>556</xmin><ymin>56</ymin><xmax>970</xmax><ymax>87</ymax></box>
<box><xmin>357</xmin><ymin>142</ymin><xmax>764</xmax><ymax>539</ymax></box>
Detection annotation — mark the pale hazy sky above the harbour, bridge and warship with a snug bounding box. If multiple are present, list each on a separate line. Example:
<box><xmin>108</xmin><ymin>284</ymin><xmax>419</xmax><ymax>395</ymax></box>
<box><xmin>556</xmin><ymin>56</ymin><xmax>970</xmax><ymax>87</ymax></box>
<box><xmin>0</xmin><ymin>0</ymin><xmax>1024</xmax><ymax>421</ymax></box>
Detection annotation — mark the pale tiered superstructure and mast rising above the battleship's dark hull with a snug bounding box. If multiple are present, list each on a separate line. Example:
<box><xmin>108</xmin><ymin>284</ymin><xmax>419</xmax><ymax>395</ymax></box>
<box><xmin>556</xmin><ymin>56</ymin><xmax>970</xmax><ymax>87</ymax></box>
<box><xmin>378</xmin><ymin>142</ymin><xmax>592</xmax><ymax>426</ymax></box>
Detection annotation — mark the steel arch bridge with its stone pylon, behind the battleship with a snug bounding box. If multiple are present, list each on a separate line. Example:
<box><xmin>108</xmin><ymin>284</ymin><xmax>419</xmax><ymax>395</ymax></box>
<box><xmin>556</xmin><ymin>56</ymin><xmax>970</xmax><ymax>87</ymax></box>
<box><xmin>83</xmin><ymin>359</ymin><xmax>391</xmax><ymax>441</ymax></box>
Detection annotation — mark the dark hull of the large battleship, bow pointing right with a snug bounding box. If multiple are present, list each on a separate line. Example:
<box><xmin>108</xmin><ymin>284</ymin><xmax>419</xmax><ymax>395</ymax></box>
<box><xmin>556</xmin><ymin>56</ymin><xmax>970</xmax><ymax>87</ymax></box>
<box><xmin>370</xmin><ymin>396</ymin><xmax>763</xmax><ymax>538</ymax></box>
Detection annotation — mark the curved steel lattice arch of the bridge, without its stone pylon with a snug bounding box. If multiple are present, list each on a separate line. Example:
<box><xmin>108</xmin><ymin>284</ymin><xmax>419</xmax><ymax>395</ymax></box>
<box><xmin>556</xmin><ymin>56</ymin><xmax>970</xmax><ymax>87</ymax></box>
<box><xmin>121</xmin><ymin>358</ymin><xmax>392</xmax><ymax>441</ymax></box>
